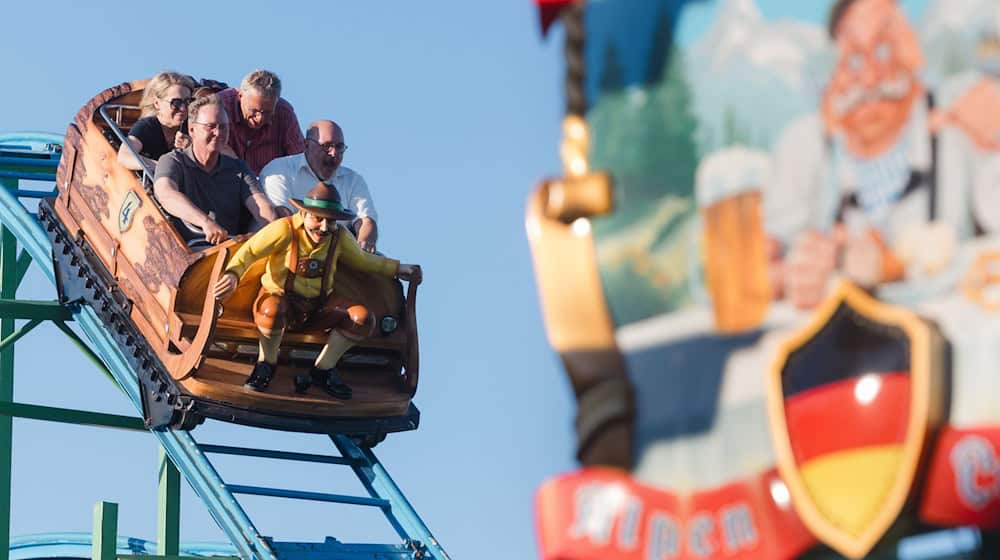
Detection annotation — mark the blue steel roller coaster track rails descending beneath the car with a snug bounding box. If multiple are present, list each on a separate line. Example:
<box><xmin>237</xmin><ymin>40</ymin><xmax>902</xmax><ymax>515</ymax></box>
<box><xmin>0</xmin><ymin>135</ymin><xmax>448</xmax><ymax>560</ymax></box>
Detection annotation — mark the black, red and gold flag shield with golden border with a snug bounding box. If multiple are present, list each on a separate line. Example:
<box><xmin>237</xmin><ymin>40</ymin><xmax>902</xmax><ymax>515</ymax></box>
<box><xmin>767</xmin><ymin>282</ymin><xmax>946</xmax><ymax>558</ymax></box>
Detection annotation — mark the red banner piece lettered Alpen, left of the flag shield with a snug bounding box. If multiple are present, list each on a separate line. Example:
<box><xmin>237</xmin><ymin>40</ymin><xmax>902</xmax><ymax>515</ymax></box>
<box><xmin>536</xmin><ymin>468</ymin><xmax>816</xmax><ymax>560</ymax></box>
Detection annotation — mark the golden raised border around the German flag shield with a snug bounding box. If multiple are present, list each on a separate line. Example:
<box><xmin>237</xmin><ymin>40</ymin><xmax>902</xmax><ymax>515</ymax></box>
<box><xmin>766</xmin><ymin>280</ymin><xmax>943</xmax><ymax>558</ymax></box>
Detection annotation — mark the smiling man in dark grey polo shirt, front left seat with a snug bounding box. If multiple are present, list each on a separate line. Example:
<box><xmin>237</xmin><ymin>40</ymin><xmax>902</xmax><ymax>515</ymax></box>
<box><xmin>153</xmin><ymin>95</ymin><xmax>276</xmax><ymax>244</ymax></box>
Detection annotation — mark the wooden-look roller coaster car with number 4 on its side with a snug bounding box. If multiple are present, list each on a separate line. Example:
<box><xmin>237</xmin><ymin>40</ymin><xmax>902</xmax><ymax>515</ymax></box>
<box><xmin>39</xmin><ymin>77</ymin><xmax>419</xmax><ymax>444</ymax></box>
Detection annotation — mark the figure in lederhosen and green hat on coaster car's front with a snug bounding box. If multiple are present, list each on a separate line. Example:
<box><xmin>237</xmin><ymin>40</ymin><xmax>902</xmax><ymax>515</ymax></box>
<box><xmin>215</xmin><ymin>183</ymin><xmax>421</xmax><ymax>399</ymax></box>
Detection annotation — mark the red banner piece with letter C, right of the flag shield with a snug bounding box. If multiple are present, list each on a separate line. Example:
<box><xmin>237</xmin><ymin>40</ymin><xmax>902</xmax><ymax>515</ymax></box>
<box><xmin>920</xmin><ymin>426</ymin><xmax>1000</xmax><ymax>529</ymax></box>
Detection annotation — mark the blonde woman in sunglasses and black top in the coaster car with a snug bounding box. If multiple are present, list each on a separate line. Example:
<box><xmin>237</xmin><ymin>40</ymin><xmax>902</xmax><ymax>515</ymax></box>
<box><xmin>118</xmin><ymin>72</ymin><xmax>195</xmax><ymax>171</ymax></box>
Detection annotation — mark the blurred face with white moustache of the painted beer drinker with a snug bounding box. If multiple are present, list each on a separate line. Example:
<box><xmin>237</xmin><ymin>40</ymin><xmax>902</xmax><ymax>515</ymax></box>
<box><xmin>823</xmin><ymin>0</ymin><xmax>923</xmax><ymax>157</ymax></box>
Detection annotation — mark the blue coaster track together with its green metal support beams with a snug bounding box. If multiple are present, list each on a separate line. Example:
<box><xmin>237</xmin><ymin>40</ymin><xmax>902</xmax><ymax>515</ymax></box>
<box><xmin>0</xmin><ymin>139</ymin><xmax>449</xmax><ymax>560</ymax></box>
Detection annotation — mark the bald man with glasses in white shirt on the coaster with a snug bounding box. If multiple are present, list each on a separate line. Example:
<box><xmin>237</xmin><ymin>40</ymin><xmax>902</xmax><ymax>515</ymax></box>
<box><xmin>260</xmin><ymin>120</ymin><xmax>378</xmax><ymax>253</ymax></box>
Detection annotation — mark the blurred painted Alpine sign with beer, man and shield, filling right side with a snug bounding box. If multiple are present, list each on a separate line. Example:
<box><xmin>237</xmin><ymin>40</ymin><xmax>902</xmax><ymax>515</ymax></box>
<box><xmin>526</xmin><ymin>0</ymin><xmax>1000</xmax><ymax>560</ymax></box>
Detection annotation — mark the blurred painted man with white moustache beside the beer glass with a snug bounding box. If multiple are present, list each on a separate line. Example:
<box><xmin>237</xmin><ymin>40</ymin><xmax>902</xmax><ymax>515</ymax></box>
<box><xmin>764</xmin><ymin>0</ymin><xmax>1000</xmax><ymax>308</ymax></box>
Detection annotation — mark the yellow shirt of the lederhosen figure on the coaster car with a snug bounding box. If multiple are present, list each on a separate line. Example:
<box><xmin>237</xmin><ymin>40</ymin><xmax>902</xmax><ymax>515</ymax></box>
<box><xmin>226</xmin><ymin>212</ymin><xmax>399</xmax><ymax>298</ymax></box>
